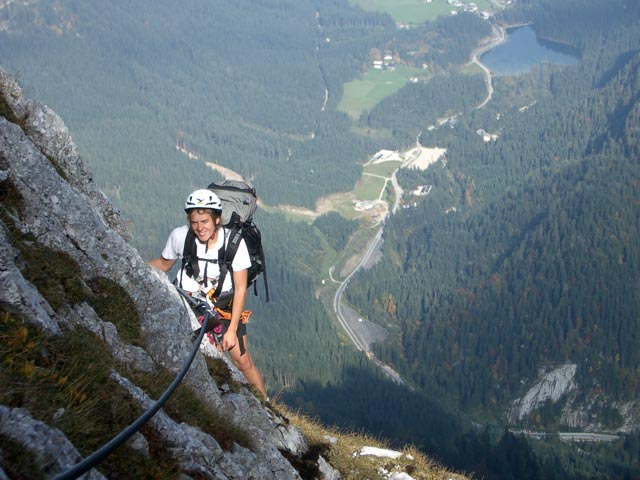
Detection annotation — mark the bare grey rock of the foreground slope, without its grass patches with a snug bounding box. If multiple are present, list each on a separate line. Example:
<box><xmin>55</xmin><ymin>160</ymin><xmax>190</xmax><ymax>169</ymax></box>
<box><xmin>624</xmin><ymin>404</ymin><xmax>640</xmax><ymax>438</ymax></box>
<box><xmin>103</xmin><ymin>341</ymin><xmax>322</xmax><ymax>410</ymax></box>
<box><xmin>0</xmin><ymin>71</ymin><xmax>307</xmax><ymax>479</ymax></box>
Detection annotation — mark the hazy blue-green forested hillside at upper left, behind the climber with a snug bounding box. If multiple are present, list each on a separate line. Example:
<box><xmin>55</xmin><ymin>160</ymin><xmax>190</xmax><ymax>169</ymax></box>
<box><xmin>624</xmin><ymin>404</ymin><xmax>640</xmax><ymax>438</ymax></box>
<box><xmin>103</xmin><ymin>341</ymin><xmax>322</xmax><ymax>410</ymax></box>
<box><xmin>0</xmin><ymin>0</ymin><xmax>395</xmax><ymax>254</ymax></box>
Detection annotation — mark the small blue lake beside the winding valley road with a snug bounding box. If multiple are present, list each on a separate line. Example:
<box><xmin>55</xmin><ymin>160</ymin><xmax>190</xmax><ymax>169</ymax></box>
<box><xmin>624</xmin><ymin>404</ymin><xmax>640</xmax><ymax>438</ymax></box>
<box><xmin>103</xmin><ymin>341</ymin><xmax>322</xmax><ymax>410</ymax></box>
<box><xmin>480</xmin><ymin>27</ymin><xmax>580</xmax><ymax>76</ymax></box>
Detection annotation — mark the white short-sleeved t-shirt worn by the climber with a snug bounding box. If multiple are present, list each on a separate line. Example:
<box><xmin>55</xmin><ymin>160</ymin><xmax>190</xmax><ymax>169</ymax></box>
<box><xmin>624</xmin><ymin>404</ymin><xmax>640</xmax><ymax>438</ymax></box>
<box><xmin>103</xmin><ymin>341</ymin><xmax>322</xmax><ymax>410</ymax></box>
<box><xmin>162</xmin><ymin>225</ymin><xmax>251</xmax><ymax>293</ymax></box>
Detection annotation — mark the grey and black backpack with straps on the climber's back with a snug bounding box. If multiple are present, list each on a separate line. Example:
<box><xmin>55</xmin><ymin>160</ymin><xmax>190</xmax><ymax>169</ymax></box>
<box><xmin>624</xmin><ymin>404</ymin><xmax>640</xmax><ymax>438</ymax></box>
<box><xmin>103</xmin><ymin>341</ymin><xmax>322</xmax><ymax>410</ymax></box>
<box><xmin>182</xmin><ymin>180</ymin><xmax>269</xmax><ymax>302</ymax></box>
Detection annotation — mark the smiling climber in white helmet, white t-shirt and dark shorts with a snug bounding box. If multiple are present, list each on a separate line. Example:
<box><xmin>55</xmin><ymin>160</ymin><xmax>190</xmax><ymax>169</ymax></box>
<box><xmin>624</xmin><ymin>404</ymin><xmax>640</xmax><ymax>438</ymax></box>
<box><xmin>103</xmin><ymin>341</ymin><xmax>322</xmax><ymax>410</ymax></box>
<box><xmin>148</xmin><ymin>190</ymin><xmax>268</xmax><ymax>400</ymax></box>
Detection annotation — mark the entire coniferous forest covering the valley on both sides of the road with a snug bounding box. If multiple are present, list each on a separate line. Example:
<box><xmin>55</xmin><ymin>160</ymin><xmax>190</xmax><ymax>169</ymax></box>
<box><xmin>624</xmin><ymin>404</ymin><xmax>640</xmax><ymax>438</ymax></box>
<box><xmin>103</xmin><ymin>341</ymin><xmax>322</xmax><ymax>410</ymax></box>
<box><xmin>0</xmin><ymin>0</ymin><xmax>640</xmax><ymax>479</ymax></box>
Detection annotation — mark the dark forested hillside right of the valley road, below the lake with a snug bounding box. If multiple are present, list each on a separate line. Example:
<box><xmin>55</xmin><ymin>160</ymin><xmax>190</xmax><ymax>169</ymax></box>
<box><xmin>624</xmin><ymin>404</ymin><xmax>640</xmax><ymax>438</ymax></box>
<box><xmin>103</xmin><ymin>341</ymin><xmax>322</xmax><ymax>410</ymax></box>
<box><xmin>349</xmin><ymin>2</ymin><xmax>640</xmax><ymax>430</ymax></box>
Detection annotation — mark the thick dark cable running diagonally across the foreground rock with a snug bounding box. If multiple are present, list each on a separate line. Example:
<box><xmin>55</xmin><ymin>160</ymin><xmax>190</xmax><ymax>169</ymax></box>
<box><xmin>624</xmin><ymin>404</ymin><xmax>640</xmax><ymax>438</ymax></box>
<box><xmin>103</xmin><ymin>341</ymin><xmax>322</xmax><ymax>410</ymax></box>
<box><xmin>53</xmin><ymin>314</ymin><xmax>211</xmax><ymax>480</ymax></box>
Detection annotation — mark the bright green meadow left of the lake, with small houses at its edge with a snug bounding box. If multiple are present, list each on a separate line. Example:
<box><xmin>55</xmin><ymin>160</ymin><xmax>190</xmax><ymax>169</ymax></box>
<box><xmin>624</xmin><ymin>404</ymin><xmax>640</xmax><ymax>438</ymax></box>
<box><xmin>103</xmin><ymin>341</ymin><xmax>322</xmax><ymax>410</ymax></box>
<box><xmin>338</xmin><ymin>67</ymin><xmax>425</xmax><ymax>118</ymax></box>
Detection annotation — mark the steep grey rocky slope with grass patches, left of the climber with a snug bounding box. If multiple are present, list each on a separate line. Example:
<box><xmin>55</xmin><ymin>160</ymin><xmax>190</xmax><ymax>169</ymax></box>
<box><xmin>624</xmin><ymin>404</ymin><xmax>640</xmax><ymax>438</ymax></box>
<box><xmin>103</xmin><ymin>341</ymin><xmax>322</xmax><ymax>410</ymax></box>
<box><xmin>0</xmin><ymin>67</ymin><xmax>307</xmax><ymax>479</ymax></box>
